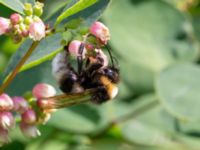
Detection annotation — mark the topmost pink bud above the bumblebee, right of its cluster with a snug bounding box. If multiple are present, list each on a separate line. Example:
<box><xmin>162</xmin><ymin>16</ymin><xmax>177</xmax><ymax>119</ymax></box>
<box><xmin>90</xmin><ymin>21</ymin><xmax>110</xmax><ymax>44</ymax></box>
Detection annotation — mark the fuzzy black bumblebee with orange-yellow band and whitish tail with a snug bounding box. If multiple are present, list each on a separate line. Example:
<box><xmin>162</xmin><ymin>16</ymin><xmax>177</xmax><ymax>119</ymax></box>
<box><xmin>52</xmin><ymin>44</ymin><xmax>120</xmax><ymax>104</ymax></box>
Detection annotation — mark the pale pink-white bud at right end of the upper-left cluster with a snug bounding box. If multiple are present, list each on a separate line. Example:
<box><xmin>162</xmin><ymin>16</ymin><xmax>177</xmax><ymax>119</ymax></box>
<box><xmin>28</xmin><ymin>20</ymin><xmax>45</xmax><ymax>41</ymax></box>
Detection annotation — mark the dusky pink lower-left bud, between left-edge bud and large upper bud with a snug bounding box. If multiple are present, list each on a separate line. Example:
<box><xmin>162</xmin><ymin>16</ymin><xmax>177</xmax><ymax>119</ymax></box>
<box><xmin>12</xmin><ymin>96</ymin><xmax>28</xmax><ymax>113</ymax></box>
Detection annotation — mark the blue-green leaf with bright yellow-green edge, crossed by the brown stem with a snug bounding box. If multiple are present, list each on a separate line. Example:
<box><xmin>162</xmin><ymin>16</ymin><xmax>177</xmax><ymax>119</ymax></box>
<box><xmin>4</xmin><ymin>34</ymin><xmax>62</xmax><ymax>80</ymax></box>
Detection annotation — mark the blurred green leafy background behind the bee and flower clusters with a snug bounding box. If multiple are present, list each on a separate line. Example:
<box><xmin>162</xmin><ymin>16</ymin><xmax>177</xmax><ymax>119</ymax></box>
<box><xmin>0</xmin><ymin>0</ymin><xmax>200</xmax><ymax>150</ymax></box>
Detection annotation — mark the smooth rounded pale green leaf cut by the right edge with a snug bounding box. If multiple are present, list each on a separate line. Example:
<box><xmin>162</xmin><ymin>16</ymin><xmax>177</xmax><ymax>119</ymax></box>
<box><xmin>156</xmin><ymin>64</ymin><xmax>200</xmax><ymax>121</ymax></box>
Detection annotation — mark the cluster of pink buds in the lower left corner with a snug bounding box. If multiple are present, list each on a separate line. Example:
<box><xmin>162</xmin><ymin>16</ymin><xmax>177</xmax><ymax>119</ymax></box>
<box><xmin>0</xmin><ymin>83</ymin><xmax>56</xmax><ymax>144</ymax></box>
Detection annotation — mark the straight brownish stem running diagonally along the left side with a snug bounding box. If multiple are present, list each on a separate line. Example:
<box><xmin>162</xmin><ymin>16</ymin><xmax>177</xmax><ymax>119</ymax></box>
<box><xmin>0</xmin><ymin>41</ymin><xmax>39</xmax><ymax>95</ymax></box>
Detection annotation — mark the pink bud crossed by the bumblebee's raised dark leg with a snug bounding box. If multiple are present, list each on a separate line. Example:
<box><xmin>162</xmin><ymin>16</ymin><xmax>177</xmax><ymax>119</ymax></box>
<box><xmin>68</xmin><ymin>40</ymin><xmax>86</xmax><ymax>58</ymax></box>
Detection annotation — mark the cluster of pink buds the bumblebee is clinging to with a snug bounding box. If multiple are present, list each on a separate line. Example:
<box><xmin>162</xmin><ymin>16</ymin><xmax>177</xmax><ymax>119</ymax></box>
<box><xmin>68</xmin><ymin>21</ymin><xmax>110</xmax><ymax>66</ymax></box>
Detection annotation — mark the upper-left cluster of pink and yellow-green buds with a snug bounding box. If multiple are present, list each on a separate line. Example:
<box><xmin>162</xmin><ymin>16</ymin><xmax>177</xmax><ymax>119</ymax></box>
<box><xmin>0</xmin><ymin>2</ymin><xmax>46</xmax><ymax>43</ymax></box>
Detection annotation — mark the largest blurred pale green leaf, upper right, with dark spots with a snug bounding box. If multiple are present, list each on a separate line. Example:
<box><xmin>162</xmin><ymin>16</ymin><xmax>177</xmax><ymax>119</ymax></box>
<box><xmin>103</xmin><ymin>0</ymin><xmax>198</xmax><ymax>94</ymax></box>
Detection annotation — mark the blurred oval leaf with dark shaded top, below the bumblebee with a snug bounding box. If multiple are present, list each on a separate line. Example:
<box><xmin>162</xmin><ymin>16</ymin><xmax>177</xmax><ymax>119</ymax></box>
<box><xmin>48</xmin><ymin>105</ymin><xmax>101</xmax><ymax>134</ymax></box>
